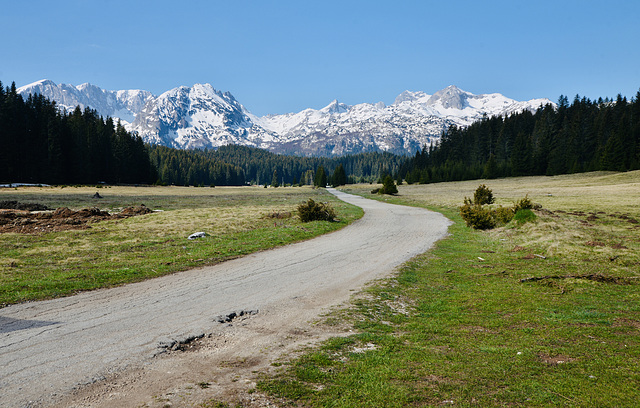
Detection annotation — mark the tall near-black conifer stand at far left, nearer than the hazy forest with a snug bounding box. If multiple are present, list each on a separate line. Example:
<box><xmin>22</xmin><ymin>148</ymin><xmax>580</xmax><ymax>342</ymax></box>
<box><xmin>0</xmin><ymin>82</ymin><xmax>157</xmax><ymax>184</ymax></box>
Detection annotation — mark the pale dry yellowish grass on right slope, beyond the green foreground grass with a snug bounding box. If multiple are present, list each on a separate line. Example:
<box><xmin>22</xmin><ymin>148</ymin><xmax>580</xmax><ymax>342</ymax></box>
<box><xmin>346</xmin><ymin>171</ymin><xmax>640</xmax><ymax>276</ymax></box>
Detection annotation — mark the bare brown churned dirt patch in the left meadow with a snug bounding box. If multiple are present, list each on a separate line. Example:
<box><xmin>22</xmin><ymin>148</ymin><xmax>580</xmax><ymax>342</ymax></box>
<box><xmin>0</xmin><ymin>202</ymin><xmax>153</xmax><ymax>234</ymax></box>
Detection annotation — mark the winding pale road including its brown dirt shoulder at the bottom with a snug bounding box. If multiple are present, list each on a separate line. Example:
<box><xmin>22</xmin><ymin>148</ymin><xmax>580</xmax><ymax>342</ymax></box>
<box><xmin>0</xmin><ymin>190</ymin><xmax>449</xmax><ymax>407</ymax></box>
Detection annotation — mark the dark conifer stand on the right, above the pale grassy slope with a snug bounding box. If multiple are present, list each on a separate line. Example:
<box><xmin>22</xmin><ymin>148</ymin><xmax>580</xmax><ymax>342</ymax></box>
<box><xmin>400</xmin><ymin>91</ymin><xmax>640</xmax><ymax>183</ymax></box>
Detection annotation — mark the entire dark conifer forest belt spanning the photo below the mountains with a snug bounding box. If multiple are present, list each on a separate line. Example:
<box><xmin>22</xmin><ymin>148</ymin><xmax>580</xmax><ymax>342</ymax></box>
<box><xmin>0</xmin><ymin>79</ymin><xmax>640</xmax><ymax>186</ymax></box>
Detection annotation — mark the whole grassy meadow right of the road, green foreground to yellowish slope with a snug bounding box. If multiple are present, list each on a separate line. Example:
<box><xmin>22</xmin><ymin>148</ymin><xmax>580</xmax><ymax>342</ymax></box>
<box><xmin>258</xmin><ymin>171</ymin><xmax>640</xmax><ymax>407</ymax></box>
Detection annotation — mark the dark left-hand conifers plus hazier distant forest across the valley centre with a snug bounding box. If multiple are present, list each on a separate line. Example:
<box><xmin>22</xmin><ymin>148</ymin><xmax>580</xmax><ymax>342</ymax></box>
<box><xmin>0</xmin><ymin>82</ymin><xmax>406</xmax><ymax>185</ymax></box>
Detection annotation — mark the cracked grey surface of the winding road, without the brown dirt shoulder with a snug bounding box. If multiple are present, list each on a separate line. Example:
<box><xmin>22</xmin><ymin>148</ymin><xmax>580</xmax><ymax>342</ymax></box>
<box><xmin>0</xmin><ymin>189</ymin><xmax>450</xmax><ymax>407</ymax></box>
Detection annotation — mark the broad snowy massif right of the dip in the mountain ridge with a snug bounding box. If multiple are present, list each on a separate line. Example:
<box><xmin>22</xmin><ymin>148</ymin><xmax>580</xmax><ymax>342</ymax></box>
<box><xmin>254</xmin><ymin>86</ymin><xmax>551</xmax><ymax>155</ymax></box>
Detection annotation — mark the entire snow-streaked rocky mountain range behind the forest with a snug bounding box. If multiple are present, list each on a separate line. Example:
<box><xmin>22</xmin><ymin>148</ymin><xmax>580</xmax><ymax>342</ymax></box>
<box><xmin>18</xmin><ymin>80</ymin><xmax>552</xmax><ymax>156</ymax></box>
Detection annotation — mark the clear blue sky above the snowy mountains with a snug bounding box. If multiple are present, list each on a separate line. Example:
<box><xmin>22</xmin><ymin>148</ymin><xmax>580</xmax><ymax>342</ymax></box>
<box><xmin>0</xmin><ymin>0</ymin><xmax>640</xmax><ymax>115</ymax></box>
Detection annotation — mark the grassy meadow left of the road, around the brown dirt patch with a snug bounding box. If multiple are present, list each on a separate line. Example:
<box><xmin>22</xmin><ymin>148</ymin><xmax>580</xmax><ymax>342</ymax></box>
<box><xmin>0</xmin><ymin>186</ymin><xmax>362</xmax><ymax>307</ymax></box>
